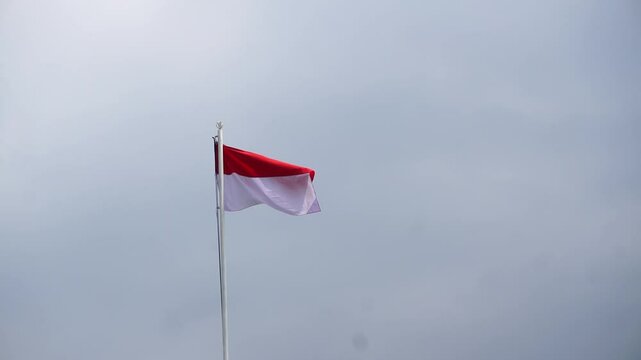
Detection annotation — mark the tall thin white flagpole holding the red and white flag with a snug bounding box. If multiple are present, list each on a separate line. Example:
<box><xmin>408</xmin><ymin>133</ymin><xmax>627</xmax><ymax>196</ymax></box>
<box><xmin>216</xmin><ymin>121</ymin><xmax>229</xmax><ymax>360</ymax></box>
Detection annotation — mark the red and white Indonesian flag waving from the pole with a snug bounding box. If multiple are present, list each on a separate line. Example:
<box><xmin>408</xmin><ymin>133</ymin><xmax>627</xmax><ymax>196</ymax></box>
<box><xmin>216</xmin><ymin>145</ymin><xmax>320</xmax><ymax>215</ymax></box>
